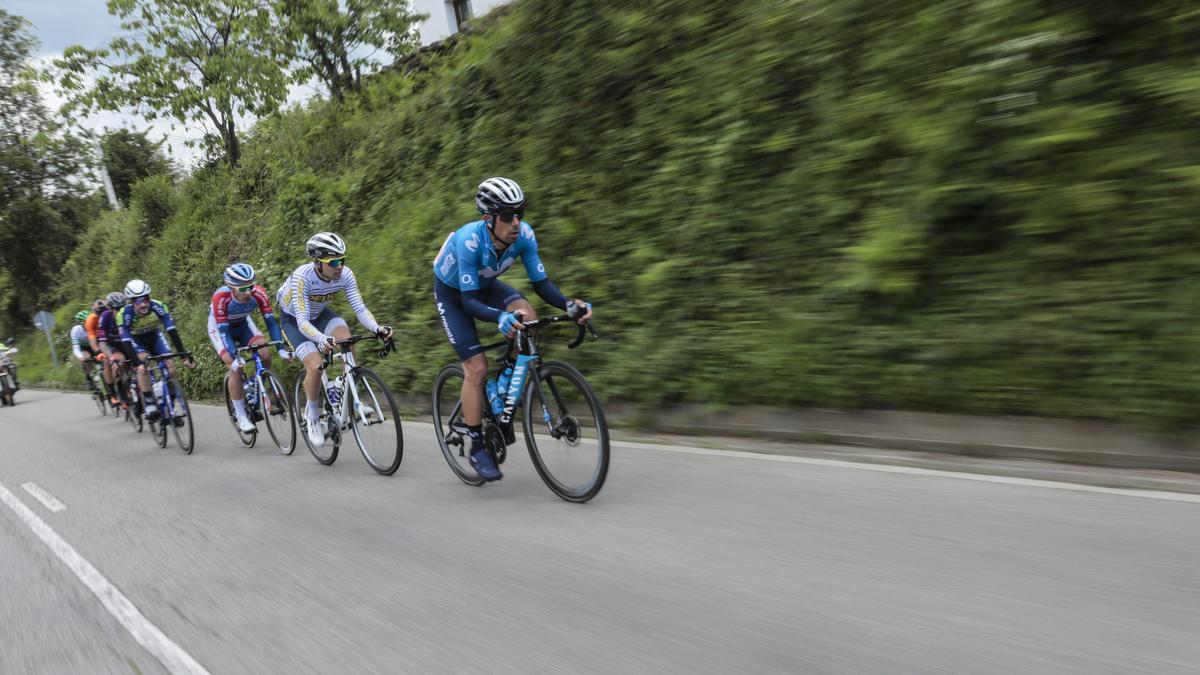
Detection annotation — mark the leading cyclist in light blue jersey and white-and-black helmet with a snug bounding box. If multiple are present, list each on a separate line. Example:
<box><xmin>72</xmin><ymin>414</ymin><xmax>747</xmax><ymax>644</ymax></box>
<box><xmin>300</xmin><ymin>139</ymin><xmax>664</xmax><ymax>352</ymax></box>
<box><xmin>433</xmin><ymin>177</ymin><xmax>592</xmax><ymax>480</ymax></box>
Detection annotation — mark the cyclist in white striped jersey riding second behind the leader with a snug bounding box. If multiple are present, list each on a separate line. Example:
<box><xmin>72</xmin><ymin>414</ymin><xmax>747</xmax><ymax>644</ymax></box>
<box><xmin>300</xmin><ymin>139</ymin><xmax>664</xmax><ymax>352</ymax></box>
<box><xmin>276</xmin><ymin>232</ymin><xmax>392</xmax><ymax>446</ymax></box>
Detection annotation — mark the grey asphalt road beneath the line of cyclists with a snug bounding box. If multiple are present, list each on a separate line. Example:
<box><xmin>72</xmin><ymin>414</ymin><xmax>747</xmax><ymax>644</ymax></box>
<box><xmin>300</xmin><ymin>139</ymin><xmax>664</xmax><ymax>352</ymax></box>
<box><xmin>0</xmin><ymin>390</ymin><xmax>1200</xmax><ymax>675</ymax></box>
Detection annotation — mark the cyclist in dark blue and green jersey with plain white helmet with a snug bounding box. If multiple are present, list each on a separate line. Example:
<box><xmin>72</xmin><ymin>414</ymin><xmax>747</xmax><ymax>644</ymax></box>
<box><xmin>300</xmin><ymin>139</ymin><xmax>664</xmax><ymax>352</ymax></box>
<box><xmin>116</xmin><ymin>279</ymin><xmax>196</xmax><ymax>422</ymax></box>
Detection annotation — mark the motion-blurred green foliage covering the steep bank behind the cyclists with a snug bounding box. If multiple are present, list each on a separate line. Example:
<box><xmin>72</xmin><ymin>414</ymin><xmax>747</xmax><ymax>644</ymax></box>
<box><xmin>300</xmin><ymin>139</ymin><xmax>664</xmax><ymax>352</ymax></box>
<box><xmin>10</xmin><ymin>0</ymin><xmax>1200</xmax><ymax>426</ymax></box>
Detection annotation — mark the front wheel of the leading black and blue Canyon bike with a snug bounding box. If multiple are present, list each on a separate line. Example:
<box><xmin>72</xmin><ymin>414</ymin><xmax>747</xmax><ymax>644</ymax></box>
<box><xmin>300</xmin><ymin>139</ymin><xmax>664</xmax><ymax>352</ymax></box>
<box><xmin>522</xmin><ymin>362</ymin><xmax>608</xmax><ymax>502</ymax></box>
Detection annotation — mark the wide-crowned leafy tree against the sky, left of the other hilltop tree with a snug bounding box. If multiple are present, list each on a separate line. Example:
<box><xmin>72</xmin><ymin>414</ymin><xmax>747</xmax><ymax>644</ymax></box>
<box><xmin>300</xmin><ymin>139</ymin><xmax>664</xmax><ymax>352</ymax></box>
<box><xmin>55</xmin><ymin>0</ymin><xmax>288</xmax><ymax>165</ymax></box>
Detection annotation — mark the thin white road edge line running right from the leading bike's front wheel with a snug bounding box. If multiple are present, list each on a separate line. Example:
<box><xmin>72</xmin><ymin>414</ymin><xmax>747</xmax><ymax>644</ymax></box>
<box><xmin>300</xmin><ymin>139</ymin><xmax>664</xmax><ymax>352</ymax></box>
<box><xmin>613</xmin><ymin>441</ymin><xmax>1200</xmax><ymax>504</ymax></box>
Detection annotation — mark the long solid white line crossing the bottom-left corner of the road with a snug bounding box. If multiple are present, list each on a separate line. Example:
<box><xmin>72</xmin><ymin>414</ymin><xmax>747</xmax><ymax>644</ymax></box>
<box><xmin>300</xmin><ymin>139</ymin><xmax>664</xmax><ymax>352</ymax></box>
<box><xmin>0</xmin><ymin>484</ymin><xmax>209</xmax><ymax>675</ymax></box>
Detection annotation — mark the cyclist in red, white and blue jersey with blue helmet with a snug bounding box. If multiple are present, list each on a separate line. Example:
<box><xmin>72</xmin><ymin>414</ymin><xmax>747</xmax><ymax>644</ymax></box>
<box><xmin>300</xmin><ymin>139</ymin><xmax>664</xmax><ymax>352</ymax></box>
<box><xmin>209</xmin><ymin>263</ymin><xmax>292</xmax><ymax>434</ymax></box>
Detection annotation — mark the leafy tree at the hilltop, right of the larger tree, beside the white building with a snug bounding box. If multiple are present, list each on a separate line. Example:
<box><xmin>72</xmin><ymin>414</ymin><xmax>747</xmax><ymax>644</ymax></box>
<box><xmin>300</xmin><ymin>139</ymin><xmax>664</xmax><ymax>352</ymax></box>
<box><xmin>275</xmin><ymin>0</ymin><xmax>416</xmax><ymax>101</ymax></box>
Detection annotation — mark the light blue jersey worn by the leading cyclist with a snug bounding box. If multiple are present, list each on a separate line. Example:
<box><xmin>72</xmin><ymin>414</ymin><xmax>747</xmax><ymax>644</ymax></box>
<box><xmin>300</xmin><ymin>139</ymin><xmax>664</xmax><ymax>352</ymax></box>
<box><xmin>433</xmin><ymin>220</ymin><xmax>546</xmax><ymax>291</ymax></box>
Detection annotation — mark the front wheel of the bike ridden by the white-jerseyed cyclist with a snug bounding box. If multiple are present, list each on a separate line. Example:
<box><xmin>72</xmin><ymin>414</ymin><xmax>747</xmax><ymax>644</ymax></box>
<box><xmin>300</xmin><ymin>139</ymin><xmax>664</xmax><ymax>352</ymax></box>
<box><xmin>348</xmin><ymin>368</ymin><xmax>404</xmax><ymax>476</ymax></box>
